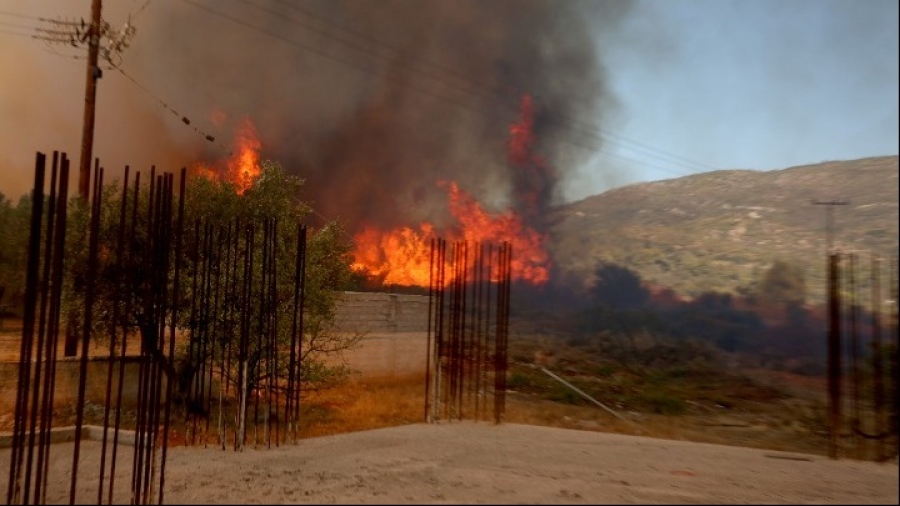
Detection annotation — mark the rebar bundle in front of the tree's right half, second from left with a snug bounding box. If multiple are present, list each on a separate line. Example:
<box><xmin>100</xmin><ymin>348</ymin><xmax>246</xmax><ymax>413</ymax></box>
<box><xmin>179</xmin><ymin>219</ymin><xmax>307</xmax><ymax>450</ymax></box>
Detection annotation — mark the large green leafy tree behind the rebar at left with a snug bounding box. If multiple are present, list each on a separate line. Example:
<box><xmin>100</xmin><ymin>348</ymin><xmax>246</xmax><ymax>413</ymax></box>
<box><xmin>66</xmin><ymin>161</ymin><xmax>359</xmax><ymax>408</ymax></box>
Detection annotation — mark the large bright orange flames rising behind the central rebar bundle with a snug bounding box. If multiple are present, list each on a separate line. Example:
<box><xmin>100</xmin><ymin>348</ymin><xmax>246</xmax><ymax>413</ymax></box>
<box><xmin>353</xmin><ymin>95</ymin><xmax>550</xmax><ymax>286</ymax></box>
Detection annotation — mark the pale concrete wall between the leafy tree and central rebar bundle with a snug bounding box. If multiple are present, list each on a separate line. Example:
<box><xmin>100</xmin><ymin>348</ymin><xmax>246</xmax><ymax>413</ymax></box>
<box><xmin>335</xmin><ymin>292</ymin><xmax>428</xmax><ymax>377</ymax></box>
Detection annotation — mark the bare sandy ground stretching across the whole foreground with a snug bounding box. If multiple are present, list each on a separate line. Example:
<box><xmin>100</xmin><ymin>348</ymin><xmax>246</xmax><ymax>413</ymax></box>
<box><xmin>0</xmin><ymin>422</ymin><xmax>900</xmax><ymax>504</ymax></box>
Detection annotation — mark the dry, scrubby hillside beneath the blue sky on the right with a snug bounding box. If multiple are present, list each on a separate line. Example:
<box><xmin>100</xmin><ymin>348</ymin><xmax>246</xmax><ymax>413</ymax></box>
<box><xmin>550</xmin><ymin>156</ymin><xmax>900</xmax><ymax>302</ymax></box>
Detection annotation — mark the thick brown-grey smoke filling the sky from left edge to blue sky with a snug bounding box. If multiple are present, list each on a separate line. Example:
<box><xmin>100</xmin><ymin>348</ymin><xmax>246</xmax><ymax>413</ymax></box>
<box><xmin>0</xmin><ymin>0</ymin><xmax>631</xmax><ymax>233</ymax></box>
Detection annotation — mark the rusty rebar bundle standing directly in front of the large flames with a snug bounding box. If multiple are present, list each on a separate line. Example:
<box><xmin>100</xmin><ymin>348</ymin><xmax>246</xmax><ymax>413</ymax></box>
<box><xmin>425</xmin><ymin>238</ymin><xmax>512</xmax><ymax>423</ymax></box>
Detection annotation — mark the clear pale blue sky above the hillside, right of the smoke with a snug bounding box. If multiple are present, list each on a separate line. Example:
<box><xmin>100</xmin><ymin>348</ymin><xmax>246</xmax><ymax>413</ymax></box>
<box><xmin>567</xmin><ymin>0</ymin><xmax>900</xmax><ymax>198</ymax></box>
